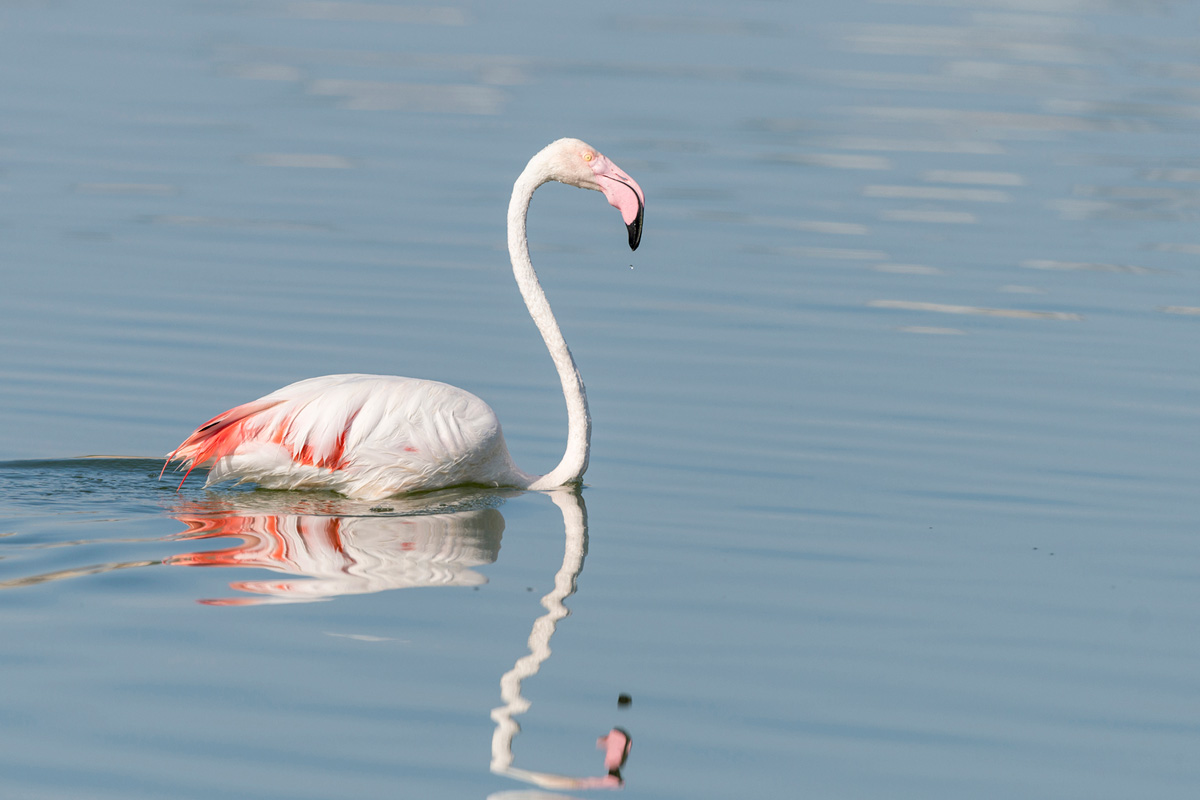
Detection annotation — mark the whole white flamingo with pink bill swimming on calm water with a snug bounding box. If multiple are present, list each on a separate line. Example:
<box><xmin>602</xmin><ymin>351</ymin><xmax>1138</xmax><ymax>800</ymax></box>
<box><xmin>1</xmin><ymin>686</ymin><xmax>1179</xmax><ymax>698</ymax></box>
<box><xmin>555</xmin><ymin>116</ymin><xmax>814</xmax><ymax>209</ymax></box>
<box><xmin>163</xmin><ymin>139</ymin><xmax>646</xmax><ymax>500</ymax></box>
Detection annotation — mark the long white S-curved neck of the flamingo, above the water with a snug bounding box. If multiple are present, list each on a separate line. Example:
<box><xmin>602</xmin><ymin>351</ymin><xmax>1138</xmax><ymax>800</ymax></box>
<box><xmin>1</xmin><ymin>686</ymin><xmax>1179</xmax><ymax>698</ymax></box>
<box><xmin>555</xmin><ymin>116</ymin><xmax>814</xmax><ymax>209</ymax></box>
<box><xmin>509</xmin><ymin>163</ymin><xmax>592</xmax><ymax>489</ymax></box>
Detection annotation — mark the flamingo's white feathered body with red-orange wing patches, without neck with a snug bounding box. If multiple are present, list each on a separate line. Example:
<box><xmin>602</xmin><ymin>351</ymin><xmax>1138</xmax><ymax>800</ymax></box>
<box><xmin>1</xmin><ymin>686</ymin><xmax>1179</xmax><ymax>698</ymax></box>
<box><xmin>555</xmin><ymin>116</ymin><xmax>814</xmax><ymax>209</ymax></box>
<box><xmin>170</xmin><ymin>374</ymin><xmax>532</xmax><ymax>498</ymax></box>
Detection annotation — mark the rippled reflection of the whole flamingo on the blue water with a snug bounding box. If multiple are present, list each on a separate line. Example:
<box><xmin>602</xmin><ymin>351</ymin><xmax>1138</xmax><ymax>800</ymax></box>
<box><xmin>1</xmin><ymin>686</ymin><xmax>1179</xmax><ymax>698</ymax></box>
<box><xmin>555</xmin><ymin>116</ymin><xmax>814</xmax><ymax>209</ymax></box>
<box><xmin>164</xmin><ymin>489</ymin><xmax>631</xmax><ymax>800</ymax></box>
